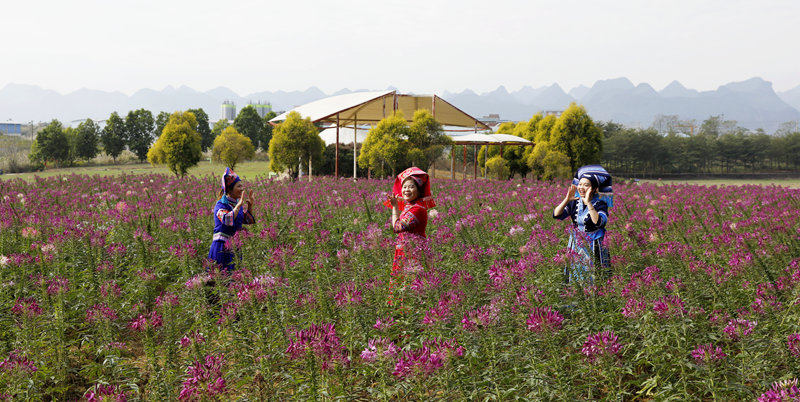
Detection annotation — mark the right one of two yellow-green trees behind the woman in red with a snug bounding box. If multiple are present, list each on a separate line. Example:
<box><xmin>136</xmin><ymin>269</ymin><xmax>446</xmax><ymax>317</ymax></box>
<box><xmin>407</xmin><ymin>109</ymin><xmax>453</xmax><ymax>169</ymax></box>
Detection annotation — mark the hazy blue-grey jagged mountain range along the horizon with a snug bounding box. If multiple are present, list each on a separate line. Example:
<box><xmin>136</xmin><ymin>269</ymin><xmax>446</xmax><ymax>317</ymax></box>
<box><xmin>0</xmin><ymin>78</ymin><xmax>800</xmax><ymax>133</ymax></box>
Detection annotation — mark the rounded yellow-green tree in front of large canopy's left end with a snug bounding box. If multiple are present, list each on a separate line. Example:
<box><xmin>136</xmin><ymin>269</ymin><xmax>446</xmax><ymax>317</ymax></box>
<box><xmin>268</xmin><ymin>112</ymin><xmax>325</xmax><ymax>177</ymax></box>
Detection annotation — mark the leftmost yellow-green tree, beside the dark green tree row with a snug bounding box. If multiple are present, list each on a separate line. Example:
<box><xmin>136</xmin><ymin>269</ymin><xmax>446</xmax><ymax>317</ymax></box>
<box><xmin>147</xmin><ymin>112</ymin><xmax>202</xmax><ymax>177</ymax></box>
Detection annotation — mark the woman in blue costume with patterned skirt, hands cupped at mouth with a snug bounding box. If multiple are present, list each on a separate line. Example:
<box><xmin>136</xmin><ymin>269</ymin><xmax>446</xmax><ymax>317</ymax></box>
<box><xmin>553</xmin><ymin>165</ymin><xmax>613</xmax><ymax>282</ymax></box>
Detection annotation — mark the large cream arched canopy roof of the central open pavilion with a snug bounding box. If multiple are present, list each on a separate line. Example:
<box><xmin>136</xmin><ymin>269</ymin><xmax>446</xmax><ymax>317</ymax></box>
<box><xmin>270</xmin><ymin>91</ymin><xmax>490</xmax><ymax>130</ymax></box>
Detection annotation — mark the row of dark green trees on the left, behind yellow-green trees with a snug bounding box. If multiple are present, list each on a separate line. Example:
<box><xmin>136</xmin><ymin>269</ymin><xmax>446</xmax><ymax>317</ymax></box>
<box><xmin>29</xmin><ymin>106</ymin><xmax>275</xmax><ymax>166</ymax></box>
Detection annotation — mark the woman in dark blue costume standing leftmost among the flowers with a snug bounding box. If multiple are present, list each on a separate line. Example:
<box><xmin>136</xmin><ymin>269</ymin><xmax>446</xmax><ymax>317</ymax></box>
<box><xmin>208</xmin><ymin>168</ymin><xmax>256</xmax><ymax>271</ymax></box>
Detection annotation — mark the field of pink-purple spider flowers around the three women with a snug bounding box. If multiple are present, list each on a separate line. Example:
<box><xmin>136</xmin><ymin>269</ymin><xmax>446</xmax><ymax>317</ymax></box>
<box><xmin>0</xmin><ymin>175</ymin><xmax>800</xmax><ymax>401</ymax></box>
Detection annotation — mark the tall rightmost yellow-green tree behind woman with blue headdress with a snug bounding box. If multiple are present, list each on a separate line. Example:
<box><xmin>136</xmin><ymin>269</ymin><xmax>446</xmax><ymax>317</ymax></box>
<box><xmin>549</xmin><ymin>103</ymin><xmax>603</xmax><ymax>171</ymax></box>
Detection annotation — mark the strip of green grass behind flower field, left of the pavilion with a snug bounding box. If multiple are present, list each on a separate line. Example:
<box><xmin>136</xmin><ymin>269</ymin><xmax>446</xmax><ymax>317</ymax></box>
<box><xmin>0</xmin><ymin>161</ymin><xmax>269</xmax><ymax>180</ymax></box>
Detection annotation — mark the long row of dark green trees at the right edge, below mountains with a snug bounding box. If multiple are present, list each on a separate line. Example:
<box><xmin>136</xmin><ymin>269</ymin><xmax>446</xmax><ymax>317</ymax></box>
<box><xmin>599</xmin><ymin>116</ymin><xmax>800</xmax><ymax>174</ymax></box>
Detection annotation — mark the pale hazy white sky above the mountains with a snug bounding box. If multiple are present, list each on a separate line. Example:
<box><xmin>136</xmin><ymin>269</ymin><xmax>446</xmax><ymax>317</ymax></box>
<box><xmin>0</xmin><ymin>0</ymin><xmax>800</xmax><ymax>96</ymax></box>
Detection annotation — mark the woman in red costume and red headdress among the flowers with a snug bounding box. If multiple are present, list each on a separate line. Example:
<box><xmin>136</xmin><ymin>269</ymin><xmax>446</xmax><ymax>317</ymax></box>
<box><xmin>384</xmin><ymin>167</ymin><xmax>436</xmax><ymax>304</ymax></box>
